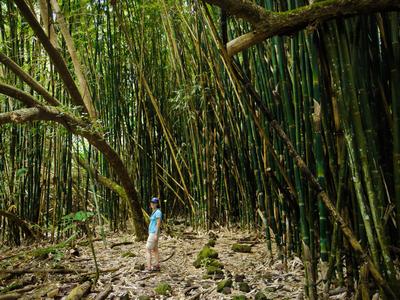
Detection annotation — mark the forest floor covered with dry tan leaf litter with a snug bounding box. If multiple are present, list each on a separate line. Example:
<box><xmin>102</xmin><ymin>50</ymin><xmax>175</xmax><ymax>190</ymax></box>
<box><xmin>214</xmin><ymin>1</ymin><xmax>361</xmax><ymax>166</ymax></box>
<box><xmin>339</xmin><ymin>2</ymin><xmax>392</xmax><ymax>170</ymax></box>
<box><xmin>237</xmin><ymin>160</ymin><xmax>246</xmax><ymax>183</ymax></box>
<box><xmin>0</xmin><ymin>228</ymin><xmax>342</xmax><ymax>299</ymax></box>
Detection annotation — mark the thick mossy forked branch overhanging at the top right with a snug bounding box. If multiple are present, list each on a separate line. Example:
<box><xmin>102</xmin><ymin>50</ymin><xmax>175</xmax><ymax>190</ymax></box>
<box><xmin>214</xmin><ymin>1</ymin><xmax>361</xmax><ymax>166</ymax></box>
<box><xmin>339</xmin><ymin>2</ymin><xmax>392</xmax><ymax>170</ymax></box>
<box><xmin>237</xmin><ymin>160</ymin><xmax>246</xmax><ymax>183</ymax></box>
<box><xmin>205</xmin><ymin>0</ymin><xmax>400</xmax><ymax>56</ymax></box>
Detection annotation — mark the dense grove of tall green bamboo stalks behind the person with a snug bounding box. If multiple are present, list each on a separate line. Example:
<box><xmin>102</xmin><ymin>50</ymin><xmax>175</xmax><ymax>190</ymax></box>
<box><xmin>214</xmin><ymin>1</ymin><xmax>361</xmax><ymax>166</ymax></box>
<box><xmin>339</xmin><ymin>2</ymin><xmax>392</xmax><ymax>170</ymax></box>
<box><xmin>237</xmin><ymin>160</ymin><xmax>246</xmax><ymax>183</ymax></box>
<box><xmin>0</xmin><ymin>0</ymin><xmax>400</xmax><ymax>299</ymax></box>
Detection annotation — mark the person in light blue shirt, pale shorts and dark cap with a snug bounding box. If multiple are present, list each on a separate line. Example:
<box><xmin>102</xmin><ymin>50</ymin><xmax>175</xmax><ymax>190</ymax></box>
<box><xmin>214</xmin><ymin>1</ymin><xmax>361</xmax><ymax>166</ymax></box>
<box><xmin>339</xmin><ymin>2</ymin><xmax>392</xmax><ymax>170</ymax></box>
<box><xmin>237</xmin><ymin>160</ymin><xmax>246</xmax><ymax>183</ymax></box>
<box><xmin>146</xmin><ymin>197</ymin><xmax>162</xmax><ymax>271</ymax></box>
